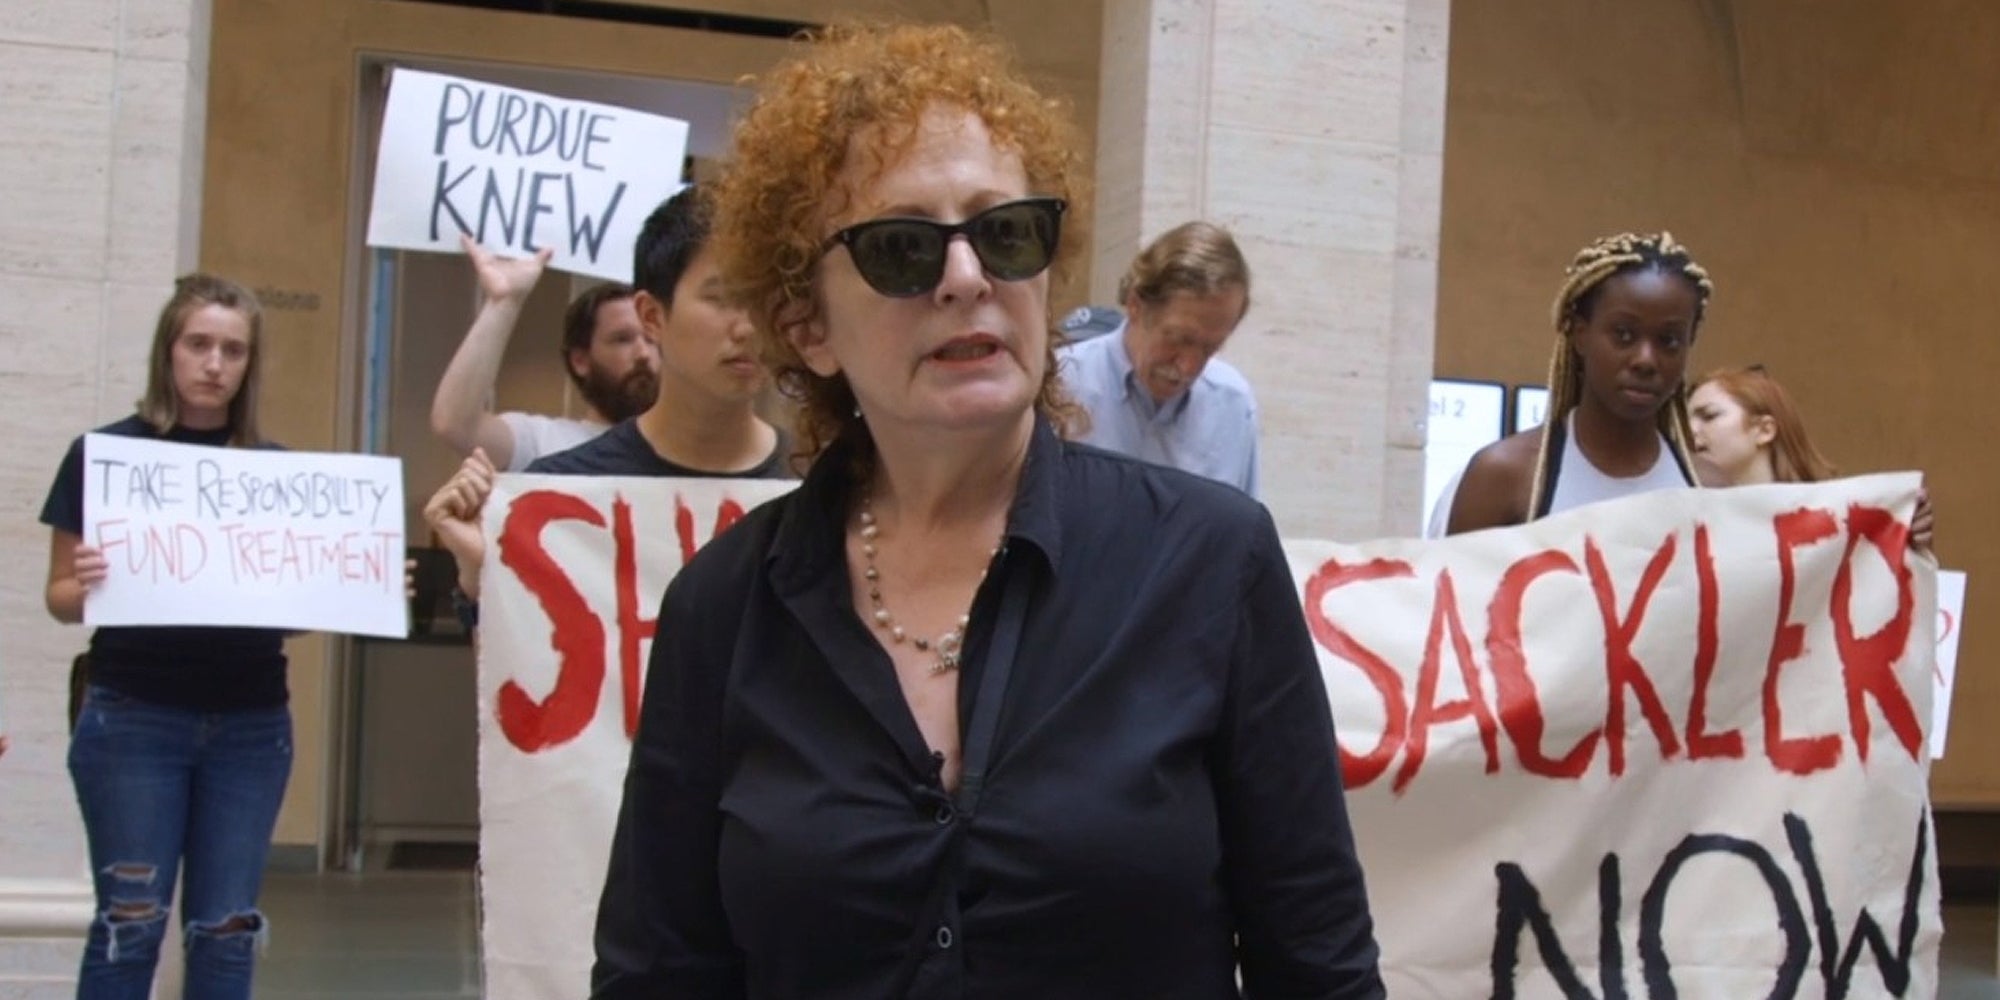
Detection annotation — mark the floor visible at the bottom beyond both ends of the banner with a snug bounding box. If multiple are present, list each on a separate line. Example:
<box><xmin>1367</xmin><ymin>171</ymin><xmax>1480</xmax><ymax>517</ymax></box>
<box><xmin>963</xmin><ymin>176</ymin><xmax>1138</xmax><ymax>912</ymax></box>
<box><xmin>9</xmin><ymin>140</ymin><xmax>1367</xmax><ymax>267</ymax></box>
<box><xmin>256</xmin><ymin>872</ymin><xmax>2000</xmax><ymax>1000</ymax></box>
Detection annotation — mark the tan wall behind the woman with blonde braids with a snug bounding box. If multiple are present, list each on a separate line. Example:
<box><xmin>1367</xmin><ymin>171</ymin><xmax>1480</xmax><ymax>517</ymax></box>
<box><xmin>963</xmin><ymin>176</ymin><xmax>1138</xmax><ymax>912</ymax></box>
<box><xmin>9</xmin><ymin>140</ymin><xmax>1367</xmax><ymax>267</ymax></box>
<box><xmin>1436</xmin><ymin>0</ymin><xmax>2000</xmax><ymax>808</ymax></box>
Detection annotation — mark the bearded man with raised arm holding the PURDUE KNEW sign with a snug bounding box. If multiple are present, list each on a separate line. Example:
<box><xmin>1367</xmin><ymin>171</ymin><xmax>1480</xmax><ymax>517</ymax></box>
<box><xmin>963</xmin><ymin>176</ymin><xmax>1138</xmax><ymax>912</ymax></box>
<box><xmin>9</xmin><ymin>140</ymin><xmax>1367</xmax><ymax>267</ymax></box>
<box><xmin>430</xmin><ymin>236</ymin><xmax>660</xmax><ymax>472</ymax></box>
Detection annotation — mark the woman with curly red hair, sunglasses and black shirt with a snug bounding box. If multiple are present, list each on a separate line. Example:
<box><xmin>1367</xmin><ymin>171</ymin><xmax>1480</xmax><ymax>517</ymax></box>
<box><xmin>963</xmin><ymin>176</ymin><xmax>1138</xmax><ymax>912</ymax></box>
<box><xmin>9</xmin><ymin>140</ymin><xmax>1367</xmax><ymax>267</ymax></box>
<box><xmin>592</xmin><ymin>17</ymin><xmax>1382</xmax><ymax>1000</ymax></box>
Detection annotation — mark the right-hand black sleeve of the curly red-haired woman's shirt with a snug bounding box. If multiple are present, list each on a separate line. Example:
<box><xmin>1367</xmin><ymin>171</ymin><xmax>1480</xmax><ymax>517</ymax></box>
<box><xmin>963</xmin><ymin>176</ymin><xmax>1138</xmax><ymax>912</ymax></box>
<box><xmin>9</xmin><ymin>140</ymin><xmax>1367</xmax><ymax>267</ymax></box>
<box><xmin>1214</xmin><ymin>512</ymin><xmax>1384</xmax><ymax>1000</ymax></box>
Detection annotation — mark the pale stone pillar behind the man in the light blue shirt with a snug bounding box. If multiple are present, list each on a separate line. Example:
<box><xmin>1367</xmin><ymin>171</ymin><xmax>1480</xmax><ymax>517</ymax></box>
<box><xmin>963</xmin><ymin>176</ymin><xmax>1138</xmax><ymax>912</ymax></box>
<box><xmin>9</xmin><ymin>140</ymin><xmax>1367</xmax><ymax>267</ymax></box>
<box><xmin>1094</xmin><ymin>0</ymin><xmax>1450</xmax><ymax>538</ymax></box>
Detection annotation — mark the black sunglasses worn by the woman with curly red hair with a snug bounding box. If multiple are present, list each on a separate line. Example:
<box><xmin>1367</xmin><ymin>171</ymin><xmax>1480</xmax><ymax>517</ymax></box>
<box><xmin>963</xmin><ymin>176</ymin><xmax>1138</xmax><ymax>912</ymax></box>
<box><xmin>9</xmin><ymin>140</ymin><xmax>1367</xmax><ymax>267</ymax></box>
<box><xmin>820</xmin><ymin>198</ymin><xmax>1068</xmax><ymax>298</ymax></box>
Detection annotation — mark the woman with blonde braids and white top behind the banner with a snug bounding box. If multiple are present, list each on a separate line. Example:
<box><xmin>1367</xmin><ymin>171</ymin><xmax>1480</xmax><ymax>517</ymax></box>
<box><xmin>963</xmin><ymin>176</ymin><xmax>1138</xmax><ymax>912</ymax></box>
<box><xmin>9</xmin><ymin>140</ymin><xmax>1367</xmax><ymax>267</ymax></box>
<box><xmin>1448</xmin><ymin>232</ymin><xmax>1714</xmax><ymax>534</ymax></box>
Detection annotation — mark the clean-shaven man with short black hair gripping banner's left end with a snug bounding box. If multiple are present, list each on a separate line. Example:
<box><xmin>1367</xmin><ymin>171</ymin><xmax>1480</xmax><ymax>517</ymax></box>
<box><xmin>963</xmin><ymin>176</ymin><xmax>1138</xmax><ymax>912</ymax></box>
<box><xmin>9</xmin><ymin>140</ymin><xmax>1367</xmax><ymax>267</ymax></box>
<box><xmin>424</xmin><ymin>188</ymin><xmax>792</xmax><ymax>608</ymax></box>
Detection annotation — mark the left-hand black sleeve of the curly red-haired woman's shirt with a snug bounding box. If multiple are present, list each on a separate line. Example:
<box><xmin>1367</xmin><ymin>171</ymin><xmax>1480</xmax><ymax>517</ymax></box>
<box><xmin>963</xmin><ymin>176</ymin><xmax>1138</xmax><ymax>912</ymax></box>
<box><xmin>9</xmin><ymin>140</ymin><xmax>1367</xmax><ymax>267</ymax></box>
<box><xmin>590</xmin><ymin>572</ymin><xmax>746</xmax><ymax>1000</ymax></box>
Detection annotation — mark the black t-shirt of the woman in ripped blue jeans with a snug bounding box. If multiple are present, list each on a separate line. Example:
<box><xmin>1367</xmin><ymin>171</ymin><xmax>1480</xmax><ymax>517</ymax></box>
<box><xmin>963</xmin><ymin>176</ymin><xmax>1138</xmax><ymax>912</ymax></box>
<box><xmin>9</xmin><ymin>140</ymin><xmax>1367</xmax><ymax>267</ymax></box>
<box><xmin>42</xmin><ymin>414</ymin><xmax>288</xmax><ymax>712</ymax></box>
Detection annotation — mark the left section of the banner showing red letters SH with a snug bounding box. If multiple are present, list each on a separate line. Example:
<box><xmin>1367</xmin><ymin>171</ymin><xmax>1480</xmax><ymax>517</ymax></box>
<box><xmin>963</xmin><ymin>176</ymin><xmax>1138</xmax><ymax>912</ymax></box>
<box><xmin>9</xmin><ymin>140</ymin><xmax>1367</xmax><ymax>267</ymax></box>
<box><xmin>478</xmin><ymin>474</ymin><xmax>796</xmax><ymax>1000</ymax></box>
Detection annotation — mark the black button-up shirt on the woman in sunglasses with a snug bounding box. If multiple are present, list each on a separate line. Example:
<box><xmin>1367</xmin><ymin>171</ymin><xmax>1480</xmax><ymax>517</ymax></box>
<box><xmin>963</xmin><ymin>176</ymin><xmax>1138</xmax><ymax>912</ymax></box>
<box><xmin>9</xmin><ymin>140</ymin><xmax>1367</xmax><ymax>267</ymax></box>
<box><xmin>592</xmin><ymin>418</ymin><xmax>1382</xmax><ymax>1000</ymax></box>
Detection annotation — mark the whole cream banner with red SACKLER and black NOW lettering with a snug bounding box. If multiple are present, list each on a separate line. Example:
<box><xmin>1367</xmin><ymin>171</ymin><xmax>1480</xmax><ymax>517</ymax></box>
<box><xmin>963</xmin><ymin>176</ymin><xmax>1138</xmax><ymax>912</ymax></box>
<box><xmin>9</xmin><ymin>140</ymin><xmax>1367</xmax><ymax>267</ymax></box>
<box><xmin>480</xmin><ymin>474</ymin><xmax>1940</xmax><ymax>1000</ymax></box>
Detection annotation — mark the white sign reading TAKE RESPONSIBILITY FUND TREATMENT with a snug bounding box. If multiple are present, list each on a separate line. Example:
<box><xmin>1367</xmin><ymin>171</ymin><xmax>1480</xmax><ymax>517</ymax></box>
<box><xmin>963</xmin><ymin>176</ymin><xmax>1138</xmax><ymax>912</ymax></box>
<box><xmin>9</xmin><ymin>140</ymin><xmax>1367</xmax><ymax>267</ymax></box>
<box><xmin>84</xmin><ymin>434</ymin><xmax>410</xmax><ymax>636</ymax></box>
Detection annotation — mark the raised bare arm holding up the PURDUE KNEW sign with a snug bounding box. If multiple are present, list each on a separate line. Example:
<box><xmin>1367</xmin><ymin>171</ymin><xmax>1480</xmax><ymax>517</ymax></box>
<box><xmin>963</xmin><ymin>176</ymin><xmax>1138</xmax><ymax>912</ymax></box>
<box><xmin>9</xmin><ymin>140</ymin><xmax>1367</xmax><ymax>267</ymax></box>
<box><xmin>430</xmin><ymin>234</ymin><xmax>552</xmax><ymax>468</ymax></box>
